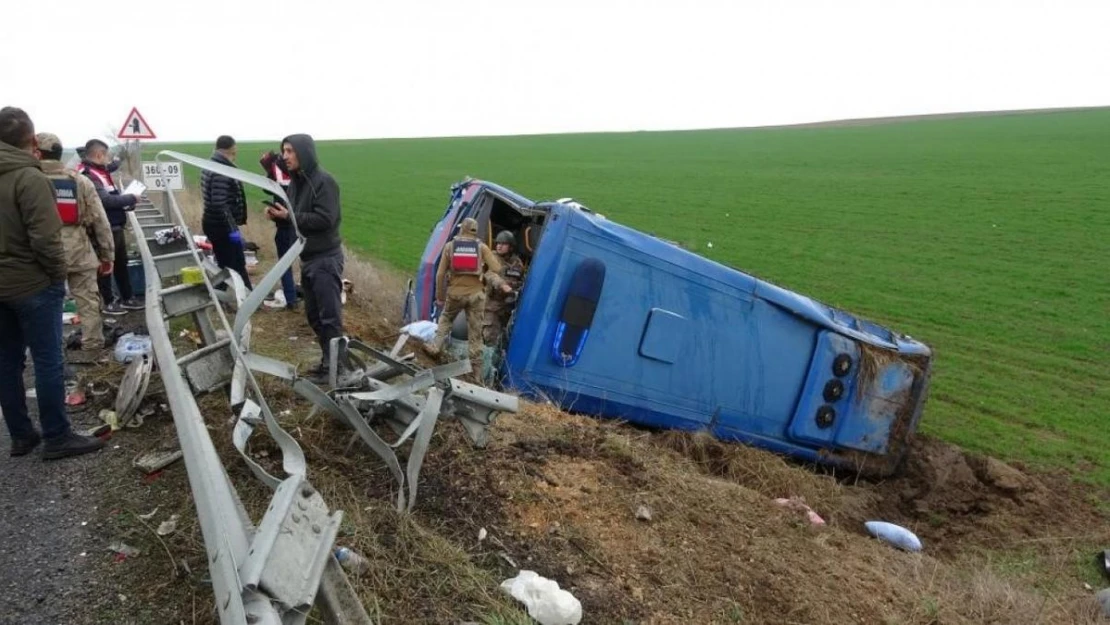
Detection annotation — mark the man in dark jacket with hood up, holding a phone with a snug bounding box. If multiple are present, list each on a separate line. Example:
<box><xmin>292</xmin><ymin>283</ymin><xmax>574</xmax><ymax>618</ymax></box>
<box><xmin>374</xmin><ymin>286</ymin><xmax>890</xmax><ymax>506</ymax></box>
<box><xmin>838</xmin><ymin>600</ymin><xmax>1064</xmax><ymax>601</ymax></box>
<box><xmin>266</xmin><ymin>134</ymin><xmax>346</xmax><ymax>381</ymax></box>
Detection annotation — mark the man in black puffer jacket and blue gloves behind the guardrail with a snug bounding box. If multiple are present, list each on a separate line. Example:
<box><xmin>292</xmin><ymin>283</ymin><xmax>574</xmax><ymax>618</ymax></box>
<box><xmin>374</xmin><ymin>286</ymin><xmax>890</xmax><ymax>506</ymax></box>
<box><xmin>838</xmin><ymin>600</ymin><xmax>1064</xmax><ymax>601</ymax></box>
<box><xmin>201</xmin><ymin>134</ymin><xmax>253</xmax><ymax>290</ymax></box>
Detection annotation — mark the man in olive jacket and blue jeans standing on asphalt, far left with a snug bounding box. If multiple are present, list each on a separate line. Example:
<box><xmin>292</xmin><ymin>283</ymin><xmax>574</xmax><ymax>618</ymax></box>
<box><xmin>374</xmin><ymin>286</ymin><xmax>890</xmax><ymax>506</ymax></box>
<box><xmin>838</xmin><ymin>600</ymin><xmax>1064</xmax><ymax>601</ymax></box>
<box><xmin>0</xmin><ymin>107</ymin><xmax>104</xmax><ymax>460</ymax></box>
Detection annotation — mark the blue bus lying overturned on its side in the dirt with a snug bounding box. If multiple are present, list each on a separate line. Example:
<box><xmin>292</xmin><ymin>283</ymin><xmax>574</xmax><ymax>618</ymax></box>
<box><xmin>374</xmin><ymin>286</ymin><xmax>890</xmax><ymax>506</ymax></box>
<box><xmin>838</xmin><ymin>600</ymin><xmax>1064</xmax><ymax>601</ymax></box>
<box><xmin>407</xmin><ymin>179</ymin><xmax>932</xmax><ymax>475</ymax></box>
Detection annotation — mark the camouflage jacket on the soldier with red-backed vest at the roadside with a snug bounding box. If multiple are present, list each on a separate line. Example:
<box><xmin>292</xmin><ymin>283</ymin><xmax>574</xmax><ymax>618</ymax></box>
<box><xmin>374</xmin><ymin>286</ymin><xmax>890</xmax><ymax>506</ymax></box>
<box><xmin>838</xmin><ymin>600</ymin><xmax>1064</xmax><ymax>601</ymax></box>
<box><xmin>42</xmin><ymin>160</ymin><xmax>115</xmax><ymax>272</ymax></box>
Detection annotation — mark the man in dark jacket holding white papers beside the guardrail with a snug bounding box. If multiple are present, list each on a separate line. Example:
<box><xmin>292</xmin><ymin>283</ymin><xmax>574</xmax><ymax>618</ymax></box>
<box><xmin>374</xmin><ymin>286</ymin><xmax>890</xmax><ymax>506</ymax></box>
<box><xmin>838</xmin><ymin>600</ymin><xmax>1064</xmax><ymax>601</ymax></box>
<box><xmin>79</xmin><ymin>139</ymin><xmax>143</xmax><ymax>315</ymax></box>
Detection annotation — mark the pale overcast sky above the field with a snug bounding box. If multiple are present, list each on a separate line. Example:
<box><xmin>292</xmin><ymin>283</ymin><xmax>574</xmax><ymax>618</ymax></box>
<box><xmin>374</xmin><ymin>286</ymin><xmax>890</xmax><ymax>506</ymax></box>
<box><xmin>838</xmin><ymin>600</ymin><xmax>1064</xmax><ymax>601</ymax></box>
<box><xmin>0</xmin><ymin>0</ymin><xmax>1110</xmax><ymax>147</ymax></box>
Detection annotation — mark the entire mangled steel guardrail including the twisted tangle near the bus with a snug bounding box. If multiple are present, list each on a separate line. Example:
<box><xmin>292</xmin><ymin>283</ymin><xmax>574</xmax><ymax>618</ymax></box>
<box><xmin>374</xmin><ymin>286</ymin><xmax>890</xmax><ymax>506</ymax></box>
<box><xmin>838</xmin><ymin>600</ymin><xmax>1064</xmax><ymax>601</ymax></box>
<box><xmin>129</xmin><ymin>150</ymin><xmax>517</xmax><ymax>625</ymax></box>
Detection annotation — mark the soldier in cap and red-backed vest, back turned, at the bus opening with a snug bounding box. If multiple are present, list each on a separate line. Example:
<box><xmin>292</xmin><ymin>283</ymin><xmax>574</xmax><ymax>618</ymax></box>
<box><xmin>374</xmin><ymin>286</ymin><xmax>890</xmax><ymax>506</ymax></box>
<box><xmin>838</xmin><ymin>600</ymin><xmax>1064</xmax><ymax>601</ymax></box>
<box><xmin>424</xmin><ymin>218</ymin><xmax>501</xmax><ymax>371</ymax></box>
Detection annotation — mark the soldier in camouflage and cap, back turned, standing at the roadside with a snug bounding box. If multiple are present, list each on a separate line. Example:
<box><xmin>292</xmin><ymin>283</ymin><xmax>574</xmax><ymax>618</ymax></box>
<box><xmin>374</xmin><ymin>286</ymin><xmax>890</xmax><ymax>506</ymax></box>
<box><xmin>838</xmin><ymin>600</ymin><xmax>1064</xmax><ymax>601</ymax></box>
<box><xmin>37</xmin><ymin>132</ymin><xmax>115</xmax><ymax>350</ymax></box>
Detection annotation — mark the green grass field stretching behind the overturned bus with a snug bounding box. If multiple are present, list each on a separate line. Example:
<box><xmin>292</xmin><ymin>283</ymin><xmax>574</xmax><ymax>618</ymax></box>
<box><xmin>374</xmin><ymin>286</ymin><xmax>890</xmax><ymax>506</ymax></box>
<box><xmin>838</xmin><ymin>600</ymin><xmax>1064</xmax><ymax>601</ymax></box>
<box><xmin>149</xmin><ymin>110</ymin><xmax>1110</xmax><ymax>485</ymax></box>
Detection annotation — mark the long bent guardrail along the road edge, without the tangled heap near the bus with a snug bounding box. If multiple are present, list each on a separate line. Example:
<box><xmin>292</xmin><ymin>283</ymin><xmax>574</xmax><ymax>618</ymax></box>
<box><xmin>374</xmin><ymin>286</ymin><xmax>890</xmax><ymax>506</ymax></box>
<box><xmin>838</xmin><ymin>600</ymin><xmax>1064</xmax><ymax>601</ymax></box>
<box><xmin>128</xmin><ymin>151</ymin><xmax>370</xmax><ymax>625</ymax></box>
